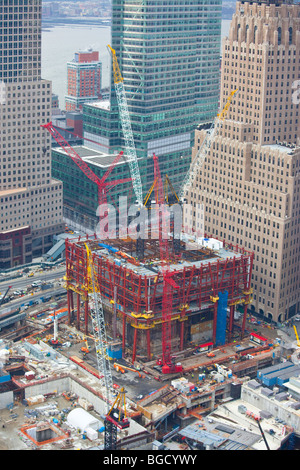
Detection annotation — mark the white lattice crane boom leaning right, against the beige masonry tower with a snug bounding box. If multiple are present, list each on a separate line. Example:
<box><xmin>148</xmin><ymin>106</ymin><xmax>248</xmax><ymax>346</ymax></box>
<box><xmin>179</xmin><ymin>90</ymin><xmax>238</xmax><ymax>201</ymax></box>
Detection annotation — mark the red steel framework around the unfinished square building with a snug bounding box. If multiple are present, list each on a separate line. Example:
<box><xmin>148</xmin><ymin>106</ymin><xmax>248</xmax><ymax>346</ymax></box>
<box><xmin>65</xmin><ymin>235</ymin><xmax>253</xmax><ymax>363</ymax></box>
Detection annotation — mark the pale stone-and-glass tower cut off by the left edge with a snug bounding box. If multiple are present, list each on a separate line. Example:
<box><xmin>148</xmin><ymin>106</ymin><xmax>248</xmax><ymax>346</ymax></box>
<box><xmin>0</xmin><ymin>0</ymin><xmax>64</xmax><ymax>269</ymax></box>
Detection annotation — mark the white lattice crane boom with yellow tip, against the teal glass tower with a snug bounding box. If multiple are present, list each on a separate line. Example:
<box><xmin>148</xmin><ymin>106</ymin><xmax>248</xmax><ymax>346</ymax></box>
<box><xmin>108</xmin><ymin>45</ymin><xmax>143</xmax><ymax>206</ymax></box>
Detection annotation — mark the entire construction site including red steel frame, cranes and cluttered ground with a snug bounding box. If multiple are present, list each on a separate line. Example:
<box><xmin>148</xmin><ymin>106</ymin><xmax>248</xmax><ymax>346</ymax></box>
<box><xmin>0</xmin><ymin>52</ymin><xmax>300</xmax><ymax>450</ymax></box>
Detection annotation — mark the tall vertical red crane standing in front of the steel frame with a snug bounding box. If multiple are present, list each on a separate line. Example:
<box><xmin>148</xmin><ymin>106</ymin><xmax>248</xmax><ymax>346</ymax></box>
<box><xmin>153</xmin><ymin>155</ymin><xmax>182</xmax><ymax>374</ymax></box>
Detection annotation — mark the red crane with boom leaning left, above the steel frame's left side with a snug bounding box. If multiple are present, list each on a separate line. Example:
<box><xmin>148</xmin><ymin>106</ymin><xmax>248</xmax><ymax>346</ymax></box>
<box><xmin>41</xmin><ymin>122</ymin><xmax>131</xmax><ymax>213</ymax></box>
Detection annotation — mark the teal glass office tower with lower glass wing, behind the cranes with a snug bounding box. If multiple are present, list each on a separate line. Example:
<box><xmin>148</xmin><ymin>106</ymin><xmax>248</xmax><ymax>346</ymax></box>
<box><xmin>84</xmin><ymin>0</ymin><xmax>221</xmax><ymax>192</ymax></box>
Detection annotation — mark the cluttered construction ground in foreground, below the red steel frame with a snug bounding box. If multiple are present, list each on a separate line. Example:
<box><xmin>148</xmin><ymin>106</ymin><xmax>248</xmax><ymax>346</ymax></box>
<box><xmin>0</xmin><ymin>301</ymin><xmax>300</xmax><ymax>450</ymax></box>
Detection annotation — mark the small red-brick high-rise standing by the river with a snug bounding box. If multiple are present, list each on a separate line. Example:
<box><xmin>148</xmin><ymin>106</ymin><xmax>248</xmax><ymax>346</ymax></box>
<box><xmin>66</xmin><ymin>50</ymin><xmax>102</xmax><ymax>111</ymax></box>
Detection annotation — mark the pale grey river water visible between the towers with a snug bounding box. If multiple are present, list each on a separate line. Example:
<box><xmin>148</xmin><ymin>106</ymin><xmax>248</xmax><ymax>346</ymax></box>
<box><xmin>42</xmin><ymin>20</ymin><xmax>231</xmax><ymax>109</ymax></box>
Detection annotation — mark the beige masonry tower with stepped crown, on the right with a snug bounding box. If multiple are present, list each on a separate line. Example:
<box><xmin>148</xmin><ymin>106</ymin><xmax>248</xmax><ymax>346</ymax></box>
<box><xmin>188</xmin><ymin>0</ymin><xmax>300</xmax><ymax>321</ymax></box>
